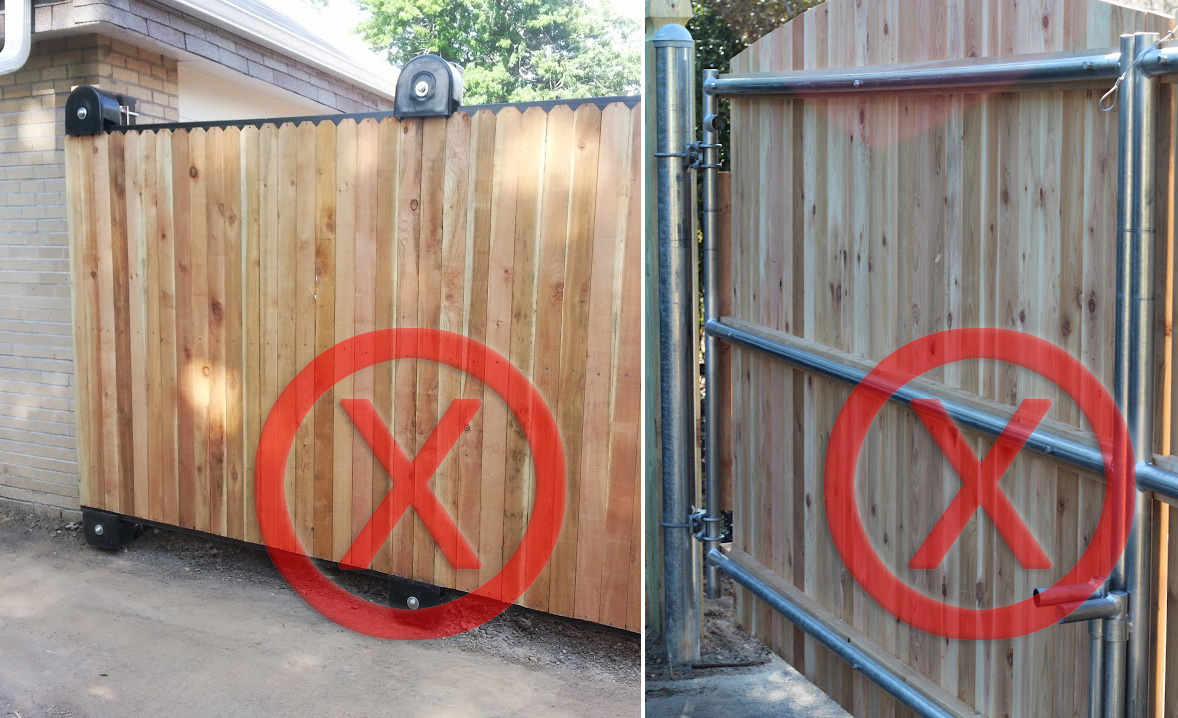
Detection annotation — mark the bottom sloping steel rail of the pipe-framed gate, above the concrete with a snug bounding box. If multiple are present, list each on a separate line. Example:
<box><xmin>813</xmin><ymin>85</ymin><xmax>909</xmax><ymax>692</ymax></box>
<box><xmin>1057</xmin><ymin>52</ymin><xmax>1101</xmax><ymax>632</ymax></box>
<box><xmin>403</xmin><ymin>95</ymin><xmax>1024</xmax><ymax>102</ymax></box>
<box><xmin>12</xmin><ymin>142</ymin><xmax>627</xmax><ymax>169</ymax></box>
<box><xmin>707</xmin><ymin>549</ymin><xmax>951</xmax><ymax>718</ymax></box>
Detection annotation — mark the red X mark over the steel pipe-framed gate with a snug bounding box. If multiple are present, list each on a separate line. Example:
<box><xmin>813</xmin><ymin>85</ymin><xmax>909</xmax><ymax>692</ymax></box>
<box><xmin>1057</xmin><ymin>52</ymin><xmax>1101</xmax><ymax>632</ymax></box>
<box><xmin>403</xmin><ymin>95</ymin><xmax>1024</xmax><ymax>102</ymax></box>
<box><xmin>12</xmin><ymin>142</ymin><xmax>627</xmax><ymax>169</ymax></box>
<box><xmin>908</xmin><ymin>399</ymin><xmax>1051</xmax><ymax>569</ymax></box>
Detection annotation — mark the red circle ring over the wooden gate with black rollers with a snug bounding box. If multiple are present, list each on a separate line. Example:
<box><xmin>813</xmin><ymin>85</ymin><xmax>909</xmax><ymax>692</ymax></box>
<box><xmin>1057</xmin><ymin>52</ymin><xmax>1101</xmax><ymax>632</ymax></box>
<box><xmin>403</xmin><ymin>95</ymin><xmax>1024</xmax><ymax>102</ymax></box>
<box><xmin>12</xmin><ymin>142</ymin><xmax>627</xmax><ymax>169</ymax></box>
<box><xmin>254</xmin><ymin>328</ymin><xmax>565</xmax><ymax>640</ymax></box>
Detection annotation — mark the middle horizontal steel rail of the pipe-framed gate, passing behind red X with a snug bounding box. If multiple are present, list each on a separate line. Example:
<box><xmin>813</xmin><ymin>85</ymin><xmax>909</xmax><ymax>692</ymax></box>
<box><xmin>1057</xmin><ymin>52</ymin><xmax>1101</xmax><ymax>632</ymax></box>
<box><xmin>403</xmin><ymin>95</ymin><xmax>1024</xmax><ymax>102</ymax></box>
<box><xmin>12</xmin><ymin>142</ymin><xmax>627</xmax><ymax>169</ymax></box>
<box><xmin>704</xmin><ymin>318</ymin><xmax>1178</xmax><ymax>506</ymax></box>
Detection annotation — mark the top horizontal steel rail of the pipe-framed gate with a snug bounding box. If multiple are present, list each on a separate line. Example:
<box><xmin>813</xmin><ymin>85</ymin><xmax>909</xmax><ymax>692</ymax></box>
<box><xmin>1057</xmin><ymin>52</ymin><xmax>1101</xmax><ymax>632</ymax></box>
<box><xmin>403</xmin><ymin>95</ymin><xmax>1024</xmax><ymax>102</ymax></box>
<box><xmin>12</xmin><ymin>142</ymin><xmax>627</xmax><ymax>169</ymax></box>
<box><xmin>703</xmin><ymin>49</ymin><xmax>1121</xmax><ymax>97</ymax></box>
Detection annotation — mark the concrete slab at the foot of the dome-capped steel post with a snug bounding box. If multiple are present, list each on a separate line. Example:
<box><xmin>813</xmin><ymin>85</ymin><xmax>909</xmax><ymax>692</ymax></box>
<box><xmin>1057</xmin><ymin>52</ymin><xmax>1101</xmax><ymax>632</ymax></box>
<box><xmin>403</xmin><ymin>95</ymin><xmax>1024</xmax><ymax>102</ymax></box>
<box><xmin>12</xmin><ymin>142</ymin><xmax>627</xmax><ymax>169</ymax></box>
<box><xmin>647</xmin><ymin>657</ymin><xmax>849</xmax><ymax>718</ymax></box>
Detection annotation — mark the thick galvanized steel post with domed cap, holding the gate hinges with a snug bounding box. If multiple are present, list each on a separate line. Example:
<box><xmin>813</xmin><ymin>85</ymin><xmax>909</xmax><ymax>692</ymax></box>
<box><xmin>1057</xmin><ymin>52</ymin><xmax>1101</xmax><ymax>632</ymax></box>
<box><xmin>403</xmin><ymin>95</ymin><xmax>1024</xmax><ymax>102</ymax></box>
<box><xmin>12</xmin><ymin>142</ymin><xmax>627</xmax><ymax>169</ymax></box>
<box><xmin>654</xmin><ymin>25</ymin><xmax>700</xmax><ymax>665</ymax></box>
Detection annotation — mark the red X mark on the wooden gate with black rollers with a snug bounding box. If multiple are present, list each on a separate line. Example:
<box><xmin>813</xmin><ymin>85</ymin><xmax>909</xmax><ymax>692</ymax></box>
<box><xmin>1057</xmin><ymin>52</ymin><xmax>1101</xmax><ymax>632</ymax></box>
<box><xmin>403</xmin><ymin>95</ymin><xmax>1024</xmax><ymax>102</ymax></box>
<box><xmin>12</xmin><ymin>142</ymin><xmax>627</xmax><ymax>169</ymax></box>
<box><xmin>339</xmin><ymin>399</ymin><xmax>483</xmax><ymax>569</ymax></box>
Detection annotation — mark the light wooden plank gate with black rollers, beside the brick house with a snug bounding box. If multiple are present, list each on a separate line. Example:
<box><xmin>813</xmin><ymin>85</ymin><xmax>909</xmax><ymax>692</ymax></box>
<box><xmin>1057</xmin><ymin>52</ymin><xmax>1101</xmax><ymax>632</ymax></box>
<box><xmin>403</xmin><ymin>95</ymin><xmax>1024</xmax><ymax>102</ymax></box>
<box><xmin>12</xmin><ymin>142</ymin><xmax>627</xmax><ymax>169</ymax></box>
<box><xmin>66</xmin><ymin>101</ymin><xmax>641</xmax><ymax>631</ymax></box>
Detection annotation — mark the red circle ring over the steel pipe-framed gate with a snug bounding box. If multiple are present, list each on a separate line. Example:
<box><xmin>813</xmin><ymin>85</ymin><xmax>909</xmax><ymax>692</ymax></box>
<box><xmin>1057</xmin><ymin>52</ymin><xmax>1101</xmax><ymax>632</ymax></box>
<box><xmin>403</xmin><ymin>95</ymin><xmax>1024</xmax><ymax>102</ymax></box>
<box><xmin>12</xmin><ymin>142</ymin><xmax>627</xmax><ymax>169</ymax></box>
<box><xmin>825</xmin><ymin>328</ymin><xmax>1136</xmax><ymax>640</ymax></box>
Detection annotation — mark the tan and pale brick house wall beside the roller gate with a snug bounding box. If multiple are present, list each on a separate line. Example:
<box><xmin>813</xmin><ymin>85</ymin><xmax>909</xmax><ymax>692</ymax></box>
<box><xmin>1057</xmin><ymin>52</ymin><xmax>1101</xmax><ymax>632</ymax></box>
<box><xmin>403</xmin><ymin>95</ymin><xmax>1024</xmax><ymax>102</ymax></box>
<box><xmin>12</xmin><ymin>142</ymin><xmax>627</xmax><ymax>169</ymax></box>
<box><xmin>0</xmin><ymin>35</ymin><xmax>177</xmax><ymax>510</ymax></box>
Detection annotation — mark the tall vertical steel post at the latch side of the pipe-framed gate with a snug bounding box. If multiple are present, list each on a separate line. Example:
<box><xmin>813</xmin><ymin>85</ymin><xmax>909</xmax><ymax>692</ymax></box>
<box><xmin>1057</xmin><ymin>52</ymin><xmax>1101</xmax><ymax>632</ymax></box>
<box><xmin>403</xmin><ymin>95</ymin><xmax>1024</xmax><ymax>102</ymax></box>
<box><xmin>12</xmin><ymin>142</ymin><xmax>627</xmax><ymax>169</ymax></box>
<box><xmin>1104</xmin><ymin>33</ymin><xmax>1158</xmax><ymax>718</ymax></box>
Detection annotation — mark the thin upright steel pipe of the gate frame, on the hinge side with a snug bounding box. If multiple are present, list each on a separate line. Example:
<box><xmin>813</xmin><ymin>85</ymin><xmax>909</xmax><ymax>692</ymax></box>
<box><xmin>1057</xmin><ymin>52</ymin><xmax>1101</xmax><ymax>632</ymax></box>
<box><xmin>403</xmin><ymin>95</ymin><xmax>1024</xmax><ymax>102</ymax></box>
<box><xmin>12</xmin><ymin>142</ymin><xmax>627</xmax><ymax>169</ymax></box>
<box><xmin>700</xmin><ymin>69</ymin><xmax>723</xmax><ymax>598</ymax></box>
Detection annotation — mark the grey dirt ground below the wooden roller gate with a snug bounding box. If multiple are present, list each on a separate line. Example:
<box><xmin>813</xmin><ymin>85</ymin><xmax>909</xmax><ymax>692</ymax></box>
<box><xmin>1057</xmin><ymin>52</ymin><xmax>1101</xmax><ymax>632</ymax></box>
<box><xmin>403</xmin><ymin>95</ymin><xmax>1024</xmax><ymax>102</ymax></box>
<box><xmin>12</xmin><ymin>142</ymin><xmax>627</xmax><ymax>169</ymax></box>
<box><xmin>0</xmin><ymin>507</ymin><xmax>642</xmax><ymax>718</ymax></box>
